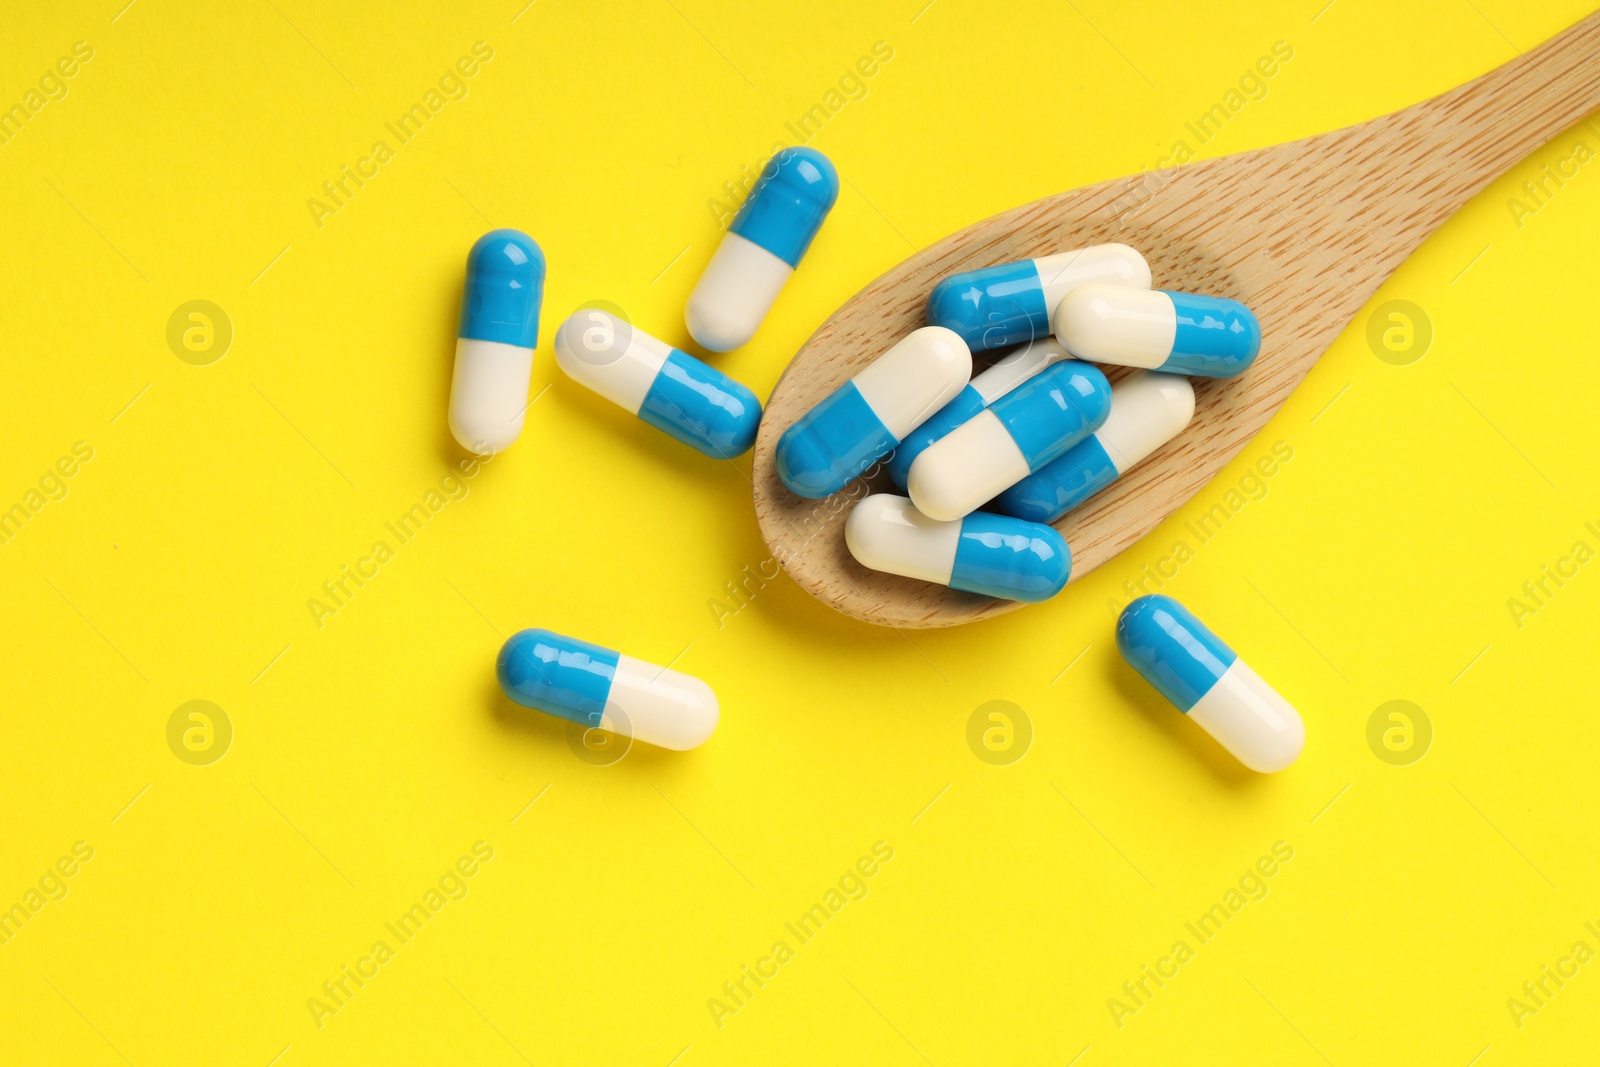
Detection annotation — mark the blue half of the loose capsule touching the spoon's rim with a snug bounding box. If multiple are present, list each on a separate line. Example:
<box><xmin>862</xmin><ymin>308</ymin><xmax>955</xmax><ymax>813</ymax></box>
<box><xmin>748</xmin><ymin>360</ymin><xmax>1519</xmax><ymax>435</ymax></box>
<box><xmin>638</xmin><ymin>349</ymin><xmax>762</xmax><ymax>459</ymax></box>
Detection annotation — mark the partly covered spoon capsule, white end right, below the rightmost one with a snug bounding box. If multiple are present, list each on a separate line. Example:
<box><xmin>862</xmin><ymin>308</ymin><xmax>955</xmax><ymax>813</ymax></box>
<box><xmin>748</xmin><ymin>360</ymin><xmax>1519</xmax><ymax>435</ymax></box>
<box><xmin>990</xmin><ymin>371</ymin><xmax>1195</xmax><ymax>523</ymax></box>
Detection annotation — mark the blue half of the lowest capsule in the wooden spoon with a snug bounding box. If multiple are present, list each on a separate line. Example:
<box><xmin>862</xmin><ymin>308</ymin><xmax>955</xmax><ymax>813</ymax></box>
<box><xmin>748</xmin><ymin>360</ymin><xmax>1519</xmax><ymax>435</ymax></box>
<box><xmin>950</xmin><ymin>512</ymin><xmax>1072</xmax><ymax>603</ymax></box>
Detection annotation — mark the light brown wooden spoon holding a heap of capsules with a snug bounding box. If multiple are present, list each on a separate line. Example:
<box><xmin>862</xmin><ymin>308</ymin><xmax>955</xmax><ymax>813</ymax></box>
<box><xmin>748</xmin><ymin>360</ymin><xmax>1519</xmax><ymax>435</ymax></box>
<box><xmin>754</xmin><ymin>13</ymin><xmax>1600</xmax><ymax>627</ymax></box>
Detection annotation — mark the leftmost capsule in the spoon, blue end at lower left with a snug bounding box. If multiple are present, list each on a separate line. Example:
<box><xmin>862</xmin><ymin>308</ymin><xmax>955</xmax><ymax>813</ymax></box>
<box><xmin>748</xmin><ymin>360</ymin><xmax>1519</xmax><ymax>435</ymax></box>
<box><xmin>774</xmin><ymin>326</ymin><xmax>972</xmax><ymax>499</ymax></box>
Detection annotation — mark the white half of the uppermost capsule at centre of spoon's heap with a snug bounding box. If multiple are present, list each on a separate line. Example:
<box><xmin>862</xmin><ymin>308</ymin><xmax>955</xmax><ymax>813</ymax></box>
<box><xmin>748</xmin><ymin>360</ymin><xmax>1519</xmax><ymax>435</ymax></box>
<box><xmin>906</xmin><ymin>408</ymin><xmax>1029</xmax><ymax>522</ymax></box>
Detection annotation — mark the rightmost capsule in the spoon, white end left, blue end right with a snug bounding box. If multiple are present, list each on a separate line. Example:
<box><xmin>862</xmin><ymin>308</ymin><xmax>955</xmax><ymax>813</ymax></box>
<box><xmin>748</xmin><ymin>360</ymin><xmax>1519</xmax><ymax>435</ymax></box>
<box><xmin>1054</xmin><ymin>285</ymin><xmax>1261</xmax><ymax>378</ymax></box>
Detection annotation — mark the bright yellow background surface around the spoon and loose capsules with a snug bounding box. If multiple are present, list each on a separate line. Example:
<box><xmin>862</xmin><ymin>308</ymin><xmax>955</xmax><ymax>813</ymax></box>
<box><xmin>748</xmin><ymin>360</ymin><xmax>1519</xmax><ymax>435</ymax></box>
<box><xmin>0</xmin><ymin>0</ymin><xmax>1600</xmax><ymax>1067</ymax></box>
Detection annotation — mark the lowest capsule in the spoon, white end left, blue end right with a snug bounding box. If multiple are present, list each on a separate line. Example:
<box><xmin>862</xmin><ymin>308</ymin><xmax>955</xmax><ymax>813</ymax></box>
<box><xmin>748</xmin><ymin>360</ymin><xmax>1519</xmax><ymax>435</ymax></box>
<box><xmin>845</xmin><ymin>493</ymin><xmax>1072</xmax><ymax>603</ymax></box>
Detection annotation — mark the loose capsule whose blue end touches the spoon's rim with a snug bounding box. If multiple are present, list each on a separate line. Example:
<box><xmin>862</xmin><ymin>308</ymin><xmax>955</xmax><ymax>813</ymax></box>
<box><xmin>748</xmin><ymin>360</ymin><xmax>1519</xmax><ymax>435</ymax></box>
<box><xmin>555</xmin><ymin>307</ymin><xmax>762</xmax><ymax>459</ymax></box>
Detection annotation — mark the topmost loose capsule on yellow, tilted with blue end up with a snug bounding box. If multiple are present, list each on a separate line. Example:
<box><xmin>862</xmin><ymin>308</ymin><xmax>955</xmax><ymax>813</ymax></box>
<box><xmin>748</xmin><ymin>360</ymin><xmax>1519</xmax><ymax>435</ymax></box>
<box><xmin>683</xmin><ymin>147</ymin><xmax>838</xmax><ymax>352</ymax></box>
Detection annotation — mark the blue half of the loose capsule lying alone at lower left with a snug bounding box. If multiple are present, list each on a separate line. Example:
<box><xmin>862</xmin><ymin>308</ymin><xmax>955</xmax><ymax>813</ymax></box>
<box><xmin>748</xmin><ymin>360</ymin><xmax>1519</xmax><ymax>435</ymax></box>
<box><xmin>494</xmin><ymin>630</ymin><xmax>619</xmax><ymax>726</ymax></box>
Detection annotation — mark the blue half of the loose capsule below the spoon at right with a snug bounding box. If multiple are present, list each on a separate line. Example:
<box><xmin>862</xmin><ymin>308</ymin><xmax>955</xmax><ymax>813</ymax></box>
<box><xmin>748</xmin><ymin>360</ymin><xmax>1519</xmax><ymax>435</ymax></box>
<box><xmin>1117</xmin><ymin>593</ymin><xmax>1238</xmax><ymax>715</ymax></box>
